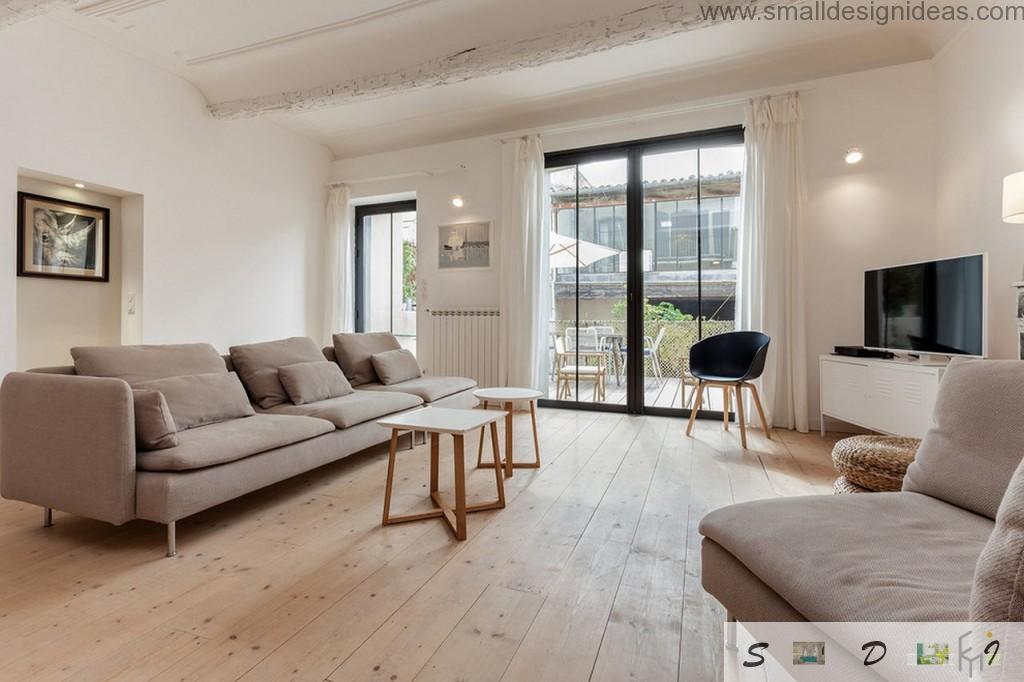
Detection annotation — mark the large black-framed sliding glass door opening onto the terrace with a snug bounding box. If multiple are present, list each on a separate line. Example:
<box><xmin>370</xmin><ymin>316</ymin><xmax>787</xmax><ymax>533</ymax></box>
<box><xmin>547</xmin><ymin>127</ymin><xmax>743</xmax><ymax>416</ymax></box>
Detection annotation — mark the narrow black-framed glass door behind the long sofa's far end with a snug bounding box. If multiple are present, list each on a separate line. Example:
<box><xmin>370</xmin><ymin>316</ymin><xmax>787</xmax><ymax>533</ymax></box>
<box><xmin>355</xmin><ymin>201</ymin><xmax>416</xmax><ymax>353</ymax></box>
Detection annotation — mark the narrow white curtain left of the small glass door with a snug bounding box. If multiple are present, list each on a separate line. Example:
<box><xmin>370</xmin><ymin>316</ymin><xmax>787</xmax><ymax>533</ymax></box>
<box><xmin>324</xmin><ymin>185</ymin><xmax>355</xmax><ymax>343</ymax></box>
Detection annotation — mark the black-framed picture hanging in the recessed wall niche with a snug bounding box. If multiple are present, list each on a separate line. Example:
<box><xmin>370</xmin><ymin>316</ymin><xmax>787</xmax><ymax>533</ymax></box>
<box><xmin>17</xmin><ymin>191</ymin><xmax>111</xmax><ymax>282</ymax></box>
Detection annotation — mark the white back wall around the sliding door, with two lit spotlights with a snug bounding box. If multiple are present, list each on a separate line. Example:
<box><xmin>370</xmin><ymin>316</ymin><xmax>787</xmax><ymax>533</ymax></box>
<box><xmin>333</xmin><ymin>62</ymin><xmax>935</xmax><ymax>422</ymax></box>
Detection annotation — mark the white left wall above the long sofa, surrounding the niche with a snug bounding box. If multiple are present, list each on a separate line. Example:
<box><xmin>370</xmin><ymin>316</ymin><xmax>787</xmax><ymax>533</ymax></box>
<box><xmin>0</xmin><ymin>18</ymin><xmax>331</xmax><ymax>372</ymax></box>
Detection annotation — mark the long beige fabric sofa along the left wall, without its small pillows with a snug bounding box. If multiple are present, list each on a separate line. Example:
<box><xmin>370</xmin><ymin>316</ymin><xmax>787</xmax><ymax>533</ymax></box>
<box><xmin>0</xmin><ymin>338</ymin><xmax>476</xmax><ymax>555</ymax></box>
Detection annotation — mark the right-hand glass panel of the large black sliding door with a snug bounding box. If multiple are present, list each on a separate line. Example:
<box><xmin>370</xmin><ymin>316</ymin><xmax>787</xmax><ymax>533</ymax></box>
<box><xmin>642</xmin><ymin>143</ymin><xmax>743</xmax><ymax>412</ymax></box>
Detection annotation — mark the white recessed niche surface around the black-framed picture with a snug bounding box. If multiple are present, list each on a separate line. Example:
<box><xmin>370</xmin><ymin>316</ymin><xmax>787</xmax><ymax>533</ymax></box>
<box><xmin>17</xmin><ymin>177</ymin><xmax>122</xmax><ymax>370</ymax></box>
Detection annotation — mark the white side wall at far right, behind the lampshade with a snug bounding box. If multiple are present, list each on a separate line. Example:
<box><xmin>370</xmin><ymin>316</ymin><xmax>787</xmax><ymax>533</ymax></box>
<box><xmin>935</xmin><ymin>23</ymin><xmax>1024</xmax><ymax>357</ymax></box>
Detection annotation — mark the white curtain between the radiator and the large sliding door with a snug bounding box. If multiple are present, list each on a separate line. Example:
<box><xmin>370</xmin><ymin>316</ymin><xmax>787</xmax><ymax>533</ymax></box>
<box><xmin>499</xmin><ymin>135</ymin><xmax>549</xmax><ymax>390</ymax></box>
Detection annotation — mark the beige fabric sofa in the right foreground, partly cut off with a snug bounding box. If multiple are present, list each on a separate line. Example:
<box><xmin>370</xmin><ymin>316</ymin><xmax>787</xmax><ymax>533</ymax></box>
<box><xmin>699</xmin><ymin>359</ymin><xmax>1024</xmax><ymax>622</ymax></box>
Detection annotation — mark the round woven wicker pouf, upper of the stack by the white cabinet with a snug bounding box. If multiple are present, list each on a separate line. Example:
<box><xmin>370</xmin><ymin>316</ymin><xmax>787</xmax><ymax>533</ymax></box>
<box><xmin>833</xmin><ymin>435</ymin><xmax>921</xmax><ymax>493</ymax></box>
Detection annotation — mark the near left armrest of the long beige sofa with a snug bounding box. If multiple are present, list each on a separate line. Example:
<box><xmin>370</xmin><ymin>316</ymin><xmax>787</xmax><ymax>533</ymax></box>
<box><xmin>0</xmin><ymin>372</ymin><xmax>135</xmax><ymax>524</ymax></box>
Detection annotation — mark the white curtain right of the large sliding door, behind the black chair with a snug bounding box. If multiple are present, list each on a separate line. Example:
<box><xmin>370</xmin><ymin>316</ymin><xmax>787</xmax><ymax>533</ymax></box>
<box><xmin>737</xmin><ymin>92</ymin><xmax>808</xmax><ymax>432</ymax></box>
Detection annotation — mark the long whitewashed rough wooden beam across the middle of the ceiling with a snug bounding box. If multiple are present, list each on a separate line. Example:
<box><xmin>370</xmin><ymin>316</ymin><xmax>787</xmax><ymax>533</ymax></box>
<box><xmin>209</xmin><ymin>0</ymin><xmax>790</xmax><ymax>119</ymax></box>
